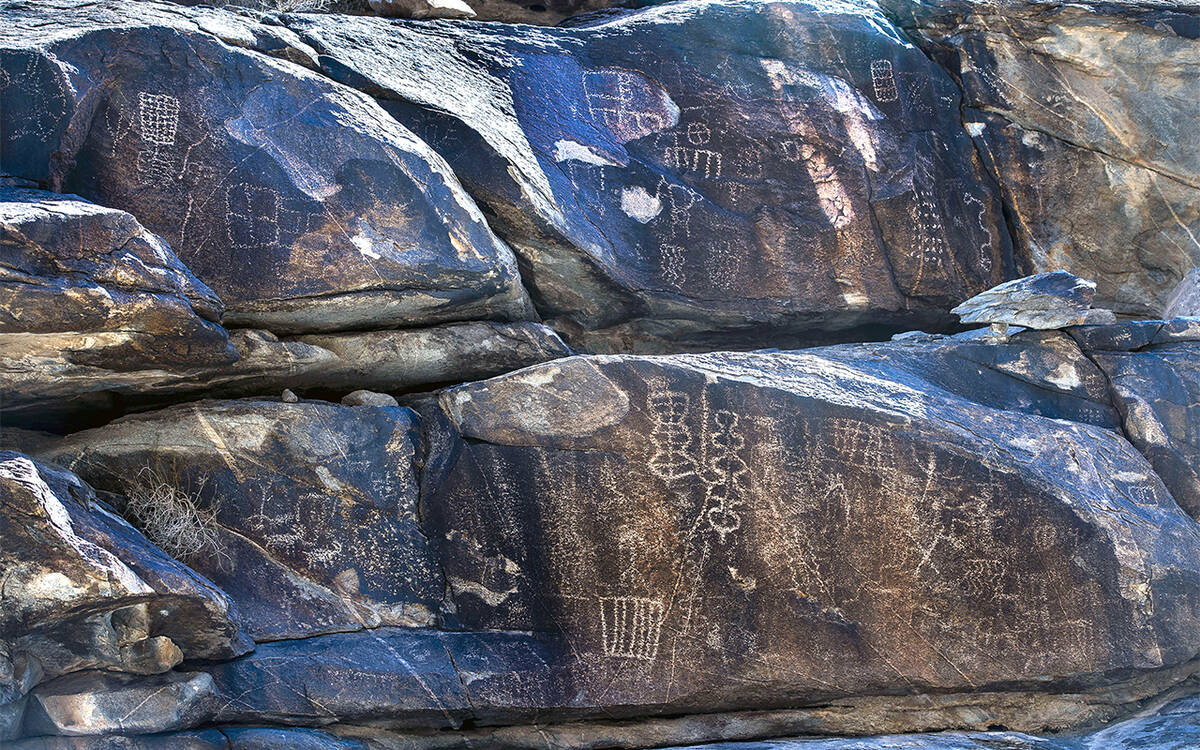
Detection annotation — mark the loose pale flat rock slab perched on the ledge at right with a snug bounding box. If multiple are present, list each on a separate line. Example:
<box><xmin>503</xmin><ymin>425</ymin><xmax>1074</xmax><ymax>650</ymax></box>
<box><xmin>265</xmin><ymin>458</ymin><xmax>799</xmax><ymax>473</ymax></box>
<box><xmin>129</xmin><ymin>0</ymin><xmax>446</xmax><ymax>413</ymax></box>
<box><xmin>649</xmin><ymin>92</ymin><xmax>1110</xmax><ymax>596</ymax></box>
<box><xmin>950</xmin><ymin>271</ymin><xmax>1096</xmax><ymax>330</ymax></box>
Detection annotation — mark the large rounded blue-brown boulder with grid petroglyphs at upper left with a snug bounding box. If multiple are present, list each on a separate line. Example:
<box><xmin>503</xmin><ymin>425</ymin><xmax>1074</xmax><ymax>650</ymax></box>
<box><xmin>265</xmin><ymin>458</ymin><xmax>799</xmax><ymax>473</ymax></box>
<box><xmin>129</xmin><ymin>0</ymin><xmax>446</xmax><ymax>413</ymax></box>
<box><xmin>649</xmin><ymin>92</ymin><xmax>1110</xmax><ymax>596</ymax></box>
<box><xmin>0</xmin><ymin>0</ymin><xmax>532</xmax><ymax>332</ymax></box>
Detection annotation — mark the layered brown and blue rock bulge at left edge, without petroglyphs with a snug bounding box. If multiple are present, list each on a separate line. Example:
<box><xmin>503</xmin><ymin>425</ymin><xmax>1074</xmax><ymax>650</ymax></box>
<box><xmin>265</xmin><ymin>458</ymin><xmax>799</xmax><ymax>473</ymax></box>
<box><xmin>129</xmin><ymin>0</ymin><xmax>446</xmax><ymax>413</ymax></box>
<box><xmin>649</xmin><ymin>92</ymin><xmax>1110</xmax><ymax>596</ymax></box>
<box><xmin>0</xmin><ymin>188</ymin><xmax>238</xmax><ymax>424</ymax></box>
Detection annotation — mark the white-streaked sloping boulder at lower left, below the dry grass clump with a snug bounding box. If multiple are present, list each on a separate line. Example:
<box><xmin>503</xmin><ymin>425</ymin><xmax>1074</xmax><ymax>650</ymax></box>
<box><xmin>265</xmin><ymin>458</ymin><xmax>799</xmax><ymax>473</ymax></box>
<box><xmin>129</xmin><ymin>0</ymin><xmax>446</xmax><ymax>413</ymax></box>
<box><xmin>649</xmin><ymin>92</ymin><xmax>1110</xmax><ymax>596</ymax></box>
<box><xmin>0</xmin><ymin>451</ymin><xmax>250</xmax><ymax>739</ymax></box>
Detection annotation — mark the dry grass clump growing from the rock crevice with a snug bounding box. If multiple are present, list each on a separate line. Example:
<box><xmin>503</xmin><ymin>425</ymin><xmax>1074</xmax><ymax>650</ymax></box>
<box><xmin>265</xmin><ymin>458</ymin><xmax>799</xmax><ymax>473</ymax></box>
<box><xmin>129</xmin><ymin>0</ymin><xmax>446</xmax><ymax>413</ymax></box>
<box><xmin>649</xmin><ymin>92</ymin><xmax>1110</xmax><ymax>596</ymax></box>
<box><xmin>119</xmin><ymin>467</ymin><xmax>230</xmax><ymax>564</ymax></box>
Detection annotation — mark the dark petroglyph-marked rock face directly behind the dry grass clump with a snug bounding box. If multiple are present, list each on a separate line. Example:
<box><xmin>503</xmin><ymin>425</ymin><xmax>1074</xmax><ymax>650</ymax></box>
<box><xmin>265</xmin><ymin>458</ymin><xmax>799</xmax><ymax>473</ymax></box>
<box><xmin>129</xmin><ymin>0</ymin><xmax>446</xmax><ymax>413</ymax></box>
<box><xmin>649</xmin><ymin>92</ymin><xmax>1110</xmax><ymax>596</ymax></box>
<box><xmin>43</xmin><ymin>400</ymin><xmax>443</xmax><ymax>641</ymax></box>
